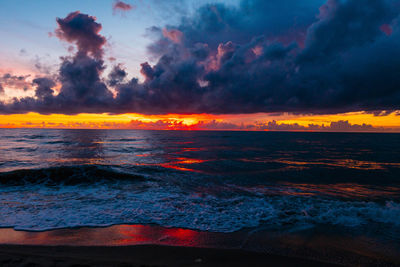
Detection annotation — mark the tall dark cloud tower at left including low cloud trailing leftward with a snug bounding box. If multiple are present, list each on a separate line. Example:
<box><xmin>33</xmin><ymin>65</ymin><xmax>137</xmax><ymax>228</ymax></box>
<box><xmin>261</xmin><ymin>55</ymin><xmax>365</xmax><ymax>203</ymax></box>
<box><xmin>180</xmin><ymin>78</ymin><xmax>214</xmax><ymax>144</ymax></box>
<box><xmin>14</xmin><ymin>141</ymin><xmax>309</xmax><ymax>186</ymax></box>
<box><xmin>2</xmin><ymin>12</ymin><xmax>114</xmax><ymax>114</ymax></box>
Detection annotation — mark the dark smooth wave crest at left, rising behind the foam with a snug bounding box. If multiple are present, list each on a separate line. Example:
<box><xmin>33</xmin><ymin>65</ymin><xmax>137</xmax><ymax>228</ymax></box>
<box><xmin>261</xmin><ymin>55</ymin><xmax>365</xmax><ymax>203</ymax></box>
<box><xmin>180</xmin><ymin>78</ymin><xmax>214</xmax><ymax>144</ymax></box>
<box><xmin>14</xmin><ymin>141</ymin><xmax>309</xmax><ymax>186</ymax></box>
<box><xmin>0</xmin><ymin>165</ymin><xmax>145</xmax><ymax>185</ymax></box>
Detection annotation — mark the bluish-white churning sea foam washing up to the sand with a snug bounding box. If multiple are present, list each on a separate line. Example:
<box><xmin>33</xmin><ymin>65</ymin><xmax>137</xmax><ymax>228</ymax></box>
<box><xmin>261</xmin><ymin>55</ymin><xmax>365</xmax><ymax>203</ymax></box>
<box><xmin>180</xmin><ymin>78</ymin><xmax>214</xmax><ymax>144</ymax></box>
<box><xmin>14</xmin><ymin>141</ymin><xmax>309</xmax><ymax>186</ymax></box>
<box><xmin>0</xmin><ymin>183</ymin><xmax>400</xmax><ymax>232</ymax></box>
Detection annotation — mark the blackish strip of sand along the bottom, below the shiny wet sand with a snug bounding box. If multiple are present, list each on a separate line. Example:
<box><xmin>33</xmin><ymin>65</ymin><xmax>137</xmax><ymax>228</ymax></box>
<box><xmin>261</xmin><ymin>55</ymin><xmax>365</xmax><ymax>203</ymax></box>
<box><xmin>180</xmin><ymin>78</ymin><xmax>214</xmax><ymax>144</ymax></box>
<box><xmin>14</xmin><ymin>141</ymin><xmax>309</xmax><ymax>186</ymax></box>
<box><xmin>0</xmin><ymin>245</ymin><xmax>335</xmax><ymax>266</ymax></box>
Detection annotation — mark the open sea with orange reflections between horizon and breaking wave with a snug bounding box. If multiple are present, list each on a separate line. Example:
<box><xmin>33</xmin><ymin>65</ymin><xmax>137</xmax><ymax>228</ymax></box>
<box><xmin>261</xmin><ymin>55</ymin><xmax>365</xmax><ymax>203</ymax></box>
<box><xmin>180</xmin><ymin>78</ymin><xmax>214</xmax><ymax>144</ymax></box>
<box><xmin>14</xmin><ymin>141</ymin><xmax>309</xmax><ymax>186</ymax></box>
<box><xmin>0</xmin><ymin>129</ymin><xmax>400</xmax><ymax>197</ymax></box>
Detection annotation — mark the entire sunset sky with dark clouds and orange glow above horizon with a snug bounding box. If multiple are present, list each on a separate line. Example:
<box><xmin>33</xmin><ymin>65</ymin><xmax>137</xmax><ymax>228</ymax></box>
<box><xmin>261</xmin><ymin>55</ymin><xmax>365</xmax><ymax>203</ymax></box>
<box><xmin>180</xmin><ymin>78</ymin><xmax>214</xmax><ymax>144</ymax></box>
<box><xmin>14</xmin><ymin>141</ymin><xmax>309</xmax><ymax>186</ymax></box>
<box><xmin>0</xmin><ymin>0</ymin><xmax>400</xmax><ymax>132</ymax></box>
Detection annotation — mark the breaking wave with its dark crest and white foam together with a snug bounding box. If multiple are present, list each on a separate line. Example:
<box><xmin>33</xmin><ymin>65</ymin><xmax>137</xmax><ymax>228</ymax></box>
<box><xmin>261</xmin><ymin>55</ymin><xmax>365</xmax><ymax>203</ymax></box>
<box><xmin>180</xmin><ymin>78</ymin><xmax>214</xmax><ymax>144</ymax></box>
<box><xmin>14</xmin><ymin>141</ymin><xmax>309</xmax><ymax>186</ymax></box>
<box><xmin>0</xmin><ymin>165</ymin><xmax>400</xmax><ymax>234</ymax></box>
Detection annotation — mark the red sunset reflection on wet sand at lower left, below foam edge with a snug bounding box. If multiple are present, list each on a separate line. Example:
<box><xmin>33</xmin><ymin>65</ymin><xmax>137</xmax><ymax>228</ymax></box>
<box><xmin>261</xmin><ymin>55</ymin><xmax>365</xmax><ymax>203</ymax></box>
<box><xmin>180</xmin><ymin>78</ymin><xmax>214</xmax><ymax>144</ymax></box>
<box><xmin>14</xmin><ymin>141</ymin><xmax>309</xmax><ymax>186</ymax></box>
<box><xmin>0</xmin><ymin>225</ymin><xmax>209</xmax><ymax>247</ymax></box>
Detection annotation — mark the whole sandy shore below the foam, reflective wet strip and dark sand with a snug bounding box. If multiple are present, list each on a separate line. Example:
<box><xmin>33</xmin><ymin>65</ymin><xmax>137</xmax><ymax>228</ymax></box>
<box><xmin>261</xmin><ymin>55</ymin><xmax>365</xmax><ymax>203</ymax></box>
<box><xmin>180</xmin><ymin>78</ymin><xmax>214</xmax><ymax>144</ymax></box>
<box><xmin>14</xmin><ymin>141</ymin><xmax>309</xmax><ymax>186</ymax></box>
<box><xmin>0</xmin><ymin>225</ymin><xmax>400</xmax><ymax>266</ymax></box>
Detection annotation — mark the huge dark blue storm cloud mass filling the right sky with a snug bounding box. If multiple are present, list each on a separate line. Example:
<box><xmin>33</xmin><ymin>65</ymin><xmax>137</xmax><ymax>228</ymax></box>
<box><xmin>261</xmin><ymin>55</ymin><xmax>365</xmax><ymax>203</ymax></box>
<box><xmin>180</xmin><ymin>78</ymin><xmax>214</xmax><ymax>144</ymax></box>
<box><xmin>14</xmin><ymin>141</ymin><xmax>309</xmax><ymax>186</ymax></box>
<box><xmin>136</xmin><ymin>0</ymin><xmax>400</xmax><ymax>113</ymax></box>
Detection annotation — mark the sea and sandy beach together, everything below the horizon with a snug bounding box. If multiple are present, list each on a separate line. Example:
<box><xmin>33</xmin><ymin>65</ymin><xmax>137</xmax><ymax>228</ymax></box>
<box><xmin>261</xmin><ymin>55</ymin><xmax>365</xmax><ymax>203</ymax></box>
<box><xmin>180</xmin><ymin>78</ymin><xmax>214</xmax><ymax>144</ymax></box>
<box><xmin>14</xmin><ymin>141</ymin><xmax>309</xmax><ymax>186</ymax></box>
<box><xmin>0</xmin><ymin>129</ymin><xmax>400</xmax><ymax>266</ymax></box>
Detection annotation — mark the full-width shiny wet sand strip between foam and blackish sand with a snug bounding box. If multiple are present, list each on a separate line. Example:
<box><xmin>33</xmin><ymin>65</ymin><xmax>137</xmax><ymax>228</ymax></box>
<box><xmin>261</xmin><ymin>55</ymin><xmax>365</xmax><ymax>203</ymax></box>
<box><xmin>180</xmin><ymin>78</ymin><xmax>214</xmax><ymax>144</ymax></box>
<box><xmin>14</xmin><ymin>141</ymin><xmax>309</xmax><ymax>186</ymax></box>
<box><xmin>0</xmin><ymin>225</ymin><xmax>400</xmax><ymax>266</ymax></box>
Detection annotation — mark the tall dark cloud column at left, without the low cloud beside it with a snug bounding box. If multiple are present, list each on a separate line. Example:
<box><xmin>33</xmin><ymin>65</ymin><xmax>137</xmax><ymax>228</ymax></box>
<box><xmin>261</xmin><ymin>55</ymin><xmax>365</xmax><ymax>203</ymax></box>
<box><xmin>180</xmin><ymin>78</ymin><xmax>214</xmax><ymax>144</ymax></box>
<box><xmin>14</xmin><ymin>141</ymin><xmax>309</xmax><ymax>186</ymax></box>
<box><xmin>49</xmin><ymin>12</ymin><xmax>113</xmax><ymax>114</ymax></box>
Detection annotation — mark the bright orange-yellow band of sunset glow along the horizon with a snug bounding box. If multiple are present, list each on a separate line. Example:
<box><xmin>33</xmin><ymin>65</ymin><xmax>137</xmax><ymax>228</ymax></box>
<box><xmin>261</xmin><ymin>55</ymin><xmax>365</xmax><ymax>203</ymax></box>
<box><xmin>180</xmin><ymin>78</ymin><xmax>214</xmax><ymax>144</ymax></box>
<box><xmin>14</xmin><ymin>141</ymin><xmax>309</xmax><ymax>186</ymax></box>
<box><xmin>0</xmin><ymin>112</ymin><xmax>400</xmax><ymax>131</ymax></box>
